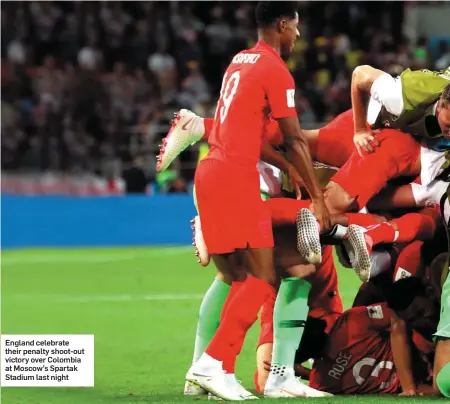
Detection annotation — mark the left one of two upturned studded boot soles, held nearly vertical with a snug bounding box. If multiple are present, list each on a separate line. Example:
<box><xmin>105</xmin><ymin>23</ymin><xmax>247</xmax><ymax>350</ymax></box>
<box><xmin>297</xmin><ymin>209</ymin><xmax>322</xmax><ymax>264</ymax></box>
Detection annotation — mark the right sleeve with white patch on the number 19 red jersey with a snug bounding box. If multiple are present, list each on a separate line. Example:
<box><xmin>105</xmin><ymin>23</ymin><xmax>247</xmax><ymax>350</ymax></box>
<box><xmin>264</xmin><ymin>61</ymin><xmax>297</xmax><ymax>119</ymax></box>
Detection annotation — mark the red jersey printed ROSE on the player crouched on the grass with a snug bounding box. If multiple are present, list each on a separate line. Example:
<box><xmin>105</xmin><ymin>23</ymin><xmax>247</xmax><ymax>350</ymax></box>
<box><xmin>310</xmin><ymin>303</ymin><xmax>400</xmax><ymax>394</ymax></box>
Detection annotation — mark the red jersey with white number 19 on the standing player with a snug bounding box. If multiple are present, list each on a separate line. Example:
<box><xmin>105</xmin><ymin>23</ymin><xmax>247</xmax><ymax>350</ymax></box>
<box><xmin>205</xmin><ymin>41</ymin><xmax>297</xmax><ymax>170</ymax></box>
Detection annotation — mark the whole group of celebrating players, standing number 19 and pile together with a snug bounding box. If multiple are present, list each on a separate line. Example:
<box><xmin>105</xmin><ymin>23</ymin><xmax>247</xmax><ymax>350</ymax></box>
<box><xmin>158</xmin><ymin>1</ymin><xmax>450</xmax><ymax>401</ymax></box>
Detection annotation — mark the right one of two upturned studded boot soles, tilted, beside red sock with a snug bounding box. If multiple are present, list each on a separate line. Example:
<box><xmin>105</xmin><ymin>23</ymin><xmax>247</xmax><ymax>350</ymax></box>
<box><xmin>344</xmin><ymin>224</ymin><xmax>373</xmax><ymax>282</ymax></box>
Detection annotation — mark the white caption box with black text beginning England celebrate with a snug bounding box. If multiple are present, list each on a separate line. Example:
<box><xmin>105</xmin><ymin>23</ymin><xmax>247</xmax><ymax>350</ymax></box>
<box><xmin>0</xmin><ymin>334</ymin><xmax>94</xmax><ymax>387</ymax></box>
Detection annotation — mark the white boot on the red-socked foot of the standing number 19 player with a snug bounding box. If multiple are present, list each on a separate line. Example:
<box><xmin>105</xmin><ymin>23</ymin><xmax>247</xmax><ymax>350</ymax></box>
<box><xmin>186</xmin><ymin>359</ymin><xmax>244</xmax><ymax>401</ymax></box>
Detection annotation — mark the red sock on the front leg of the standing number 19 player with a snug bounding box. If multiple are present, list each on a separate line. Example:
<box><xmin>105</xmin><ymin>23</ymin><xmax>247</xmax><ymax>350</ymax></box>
<box><xmin>205</xmin><ymin>276</ymin><xmax>275</xmax><ymax>361</ymax></box>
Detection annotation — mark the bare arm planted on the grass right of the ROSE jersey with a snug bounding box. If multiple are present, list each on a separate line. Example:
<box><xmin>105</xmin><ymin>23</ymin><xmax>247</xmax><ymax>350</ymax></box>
<box><xmin>391</xmin><ymin>313</ymin><xmax>417</xmax><ymax>396</ymax></box>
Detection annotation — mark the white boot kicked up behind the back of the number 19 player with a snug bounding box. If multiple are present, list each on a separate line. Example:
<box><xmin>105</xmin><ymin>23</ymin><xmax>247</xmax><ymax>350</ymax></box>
<box><xmin>156</xmin><ymin>109</ymin><xmax>205</xmax><ymax>171</ymax></box>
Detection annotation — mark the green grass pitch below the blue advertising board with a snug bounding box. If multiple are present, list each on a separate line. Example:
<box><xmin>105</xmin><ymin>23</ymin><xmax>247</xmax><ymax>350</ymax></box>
<box><xmin>1</xmin><ymin>247</ymin><xmax>441</xmax><ymax>404</ymax></box>
